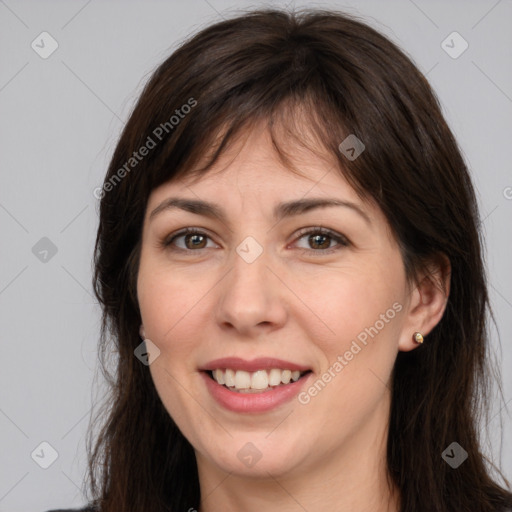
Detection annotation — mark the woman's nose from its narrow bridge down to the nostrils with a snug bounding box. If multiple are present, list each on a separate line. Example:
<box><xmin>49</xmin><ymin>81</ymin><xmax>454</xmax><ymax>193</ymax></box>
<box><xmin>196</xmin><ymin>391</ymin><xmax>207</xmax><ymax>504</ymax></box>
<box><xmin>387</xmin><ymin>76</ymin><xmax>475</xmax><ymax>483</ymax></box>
<box><xmin>217</xmin><ymin>237</ymin><xmax>286</xmax><ymax>334</ymax></box>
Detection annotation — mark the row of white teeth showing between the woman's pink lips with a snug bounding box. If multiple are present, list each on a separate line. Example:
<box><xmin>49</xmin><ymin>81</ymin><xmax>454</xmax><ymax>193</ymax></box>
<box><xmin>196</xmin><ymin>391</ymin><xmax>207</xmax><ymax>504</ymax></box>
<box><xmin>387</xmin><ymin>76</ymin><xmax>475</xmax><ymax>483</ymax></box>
<box><xmin>207</xmin><ymin>368</ymin><xmax>311</xmax><ymax>393</ymax></box>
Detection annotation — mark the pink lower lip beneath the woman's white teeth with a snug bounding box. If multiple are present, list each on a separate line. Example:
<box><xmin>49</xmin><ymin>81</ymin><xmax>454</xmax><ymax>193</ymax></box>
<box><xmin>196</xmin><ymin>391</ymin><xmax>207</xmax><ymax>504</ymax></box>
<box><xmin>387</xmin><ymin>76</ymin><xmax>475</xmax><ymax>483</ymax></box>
<box><xmin>201</xmin><ymin>372</ymin><xmax>311</xmax><ymax>412</ymax></box>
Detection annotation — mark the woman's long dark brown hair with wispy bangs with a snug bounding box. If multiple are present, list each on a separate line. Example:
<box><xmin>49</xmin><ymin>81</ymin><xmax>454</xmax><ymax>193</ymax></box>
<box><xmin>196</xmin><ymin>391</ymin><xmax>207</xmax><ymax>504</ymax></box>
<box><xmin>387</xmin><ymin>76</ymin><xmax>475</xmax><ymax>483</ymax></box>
<box><xmin>88</xmin><ymin>10</ymin><xmax>512</xmax><ymax>512</ymax></box>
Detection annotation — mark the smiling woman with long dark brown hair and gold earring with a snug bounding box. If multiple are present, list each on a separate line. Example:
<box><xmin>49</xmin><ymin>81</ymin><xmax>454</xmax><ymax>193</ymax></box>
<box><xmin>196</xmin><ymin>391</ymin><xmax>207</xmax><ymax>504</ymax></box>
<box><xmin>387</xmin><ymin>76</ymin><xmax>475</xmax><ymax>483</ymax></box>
<box><xmin>46</xmin><ymin>10</ymin><xmax>512</xmax><ymax>512</ymax></box>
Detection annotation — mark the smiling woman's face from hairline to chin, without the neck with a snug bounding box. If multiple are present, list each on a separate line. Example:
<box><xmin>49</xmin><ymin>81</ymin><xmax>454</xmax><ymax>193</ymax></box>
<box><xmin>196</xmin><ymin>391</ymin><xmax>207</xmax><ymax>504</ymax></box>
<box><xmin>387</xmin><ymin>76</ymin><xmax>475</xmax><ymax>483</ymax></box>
<box><xmin>138</xmin><ymin>126</ymin><xmax>420</xmax><ymax>482</ymax></box>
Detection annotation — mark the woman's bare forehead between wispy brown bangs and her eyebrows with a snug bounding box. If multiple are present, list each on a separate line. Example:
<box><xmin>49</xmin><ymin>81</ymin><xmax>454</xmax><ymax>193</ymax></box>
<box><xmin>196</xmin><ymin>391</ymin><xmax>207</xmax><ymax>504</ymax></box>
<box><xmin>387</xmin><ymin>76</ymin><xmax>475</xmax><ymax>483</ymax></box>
<box><xmin>150</xmin><ymin>126</ymin><xmax>361</xmax><ymax>205</ymax></box>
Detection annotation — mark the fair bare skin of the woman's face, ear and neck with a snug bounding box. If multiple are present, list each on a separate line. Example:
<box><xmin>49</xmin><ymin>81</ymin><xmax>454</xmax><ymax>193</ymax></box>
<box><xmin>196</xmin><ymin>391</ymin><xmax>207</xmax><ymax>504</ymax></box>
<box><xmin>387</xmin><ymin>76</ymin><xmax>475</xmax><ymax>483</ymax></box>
<box><xmin>137</xmin><ymin>122</ymin><xmax>448</xmax><ymax>512</ymax></box>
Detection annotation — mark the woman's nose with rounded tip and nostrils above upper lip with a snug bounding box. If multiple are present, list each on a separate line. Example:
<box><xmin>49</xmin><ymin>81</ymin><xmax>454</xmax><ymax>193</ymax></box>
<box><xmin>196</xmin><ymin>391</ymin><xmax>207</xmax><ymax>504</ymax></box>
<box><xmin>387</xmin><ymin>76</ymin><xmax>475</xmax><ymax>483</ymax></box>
<box><xmin>216</xmin><ymin>246</ymin><xmax>288</xmax><ymax>338</ymax></box>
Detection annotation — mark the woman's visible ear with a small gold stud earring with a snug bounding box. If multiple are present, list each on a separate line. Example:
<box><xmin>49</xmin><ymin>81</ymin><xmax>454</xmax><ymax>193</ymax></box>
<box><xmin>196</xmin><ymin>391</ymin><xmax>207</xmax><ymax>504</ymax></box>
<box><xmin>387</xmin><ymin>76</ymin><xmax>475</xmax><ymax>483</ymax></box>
<box><xmin>398</xmin><ymin>255</ymin><xmax>451</xmax><ymax>352</ymax></box>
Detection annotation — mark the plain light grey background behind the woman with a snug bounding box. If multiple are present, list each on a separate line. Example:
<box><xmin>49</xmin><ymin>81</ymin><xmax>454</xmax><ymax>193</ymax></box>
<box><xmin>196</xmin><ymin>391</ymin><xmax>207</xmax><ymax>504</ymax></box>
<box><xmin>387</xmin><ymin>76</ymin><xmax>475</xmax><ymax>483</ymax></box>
<box><xmin>0</xmin><ymin>0</ymin><xmax>512</xmax><ymax>512</ymax></box>
